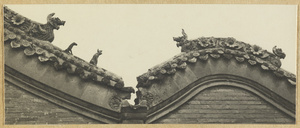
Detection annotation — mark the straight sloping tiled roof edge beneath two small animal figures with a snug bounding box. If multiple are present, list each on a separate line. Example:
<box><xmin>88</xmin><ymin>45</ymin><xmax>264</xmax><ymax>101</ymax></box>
<box><xmin>4</xmin><ymin>7</ymin><xmax>134</xmax><ymax>92</ymax></box>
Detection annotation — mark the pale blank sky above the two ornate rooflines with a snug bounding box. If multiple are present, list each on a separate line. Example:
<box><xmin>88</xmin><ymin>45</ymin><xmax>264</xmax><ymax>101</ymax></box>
<box><xmin>7</xmin><ymin>4</ymin><xmax>297</xmax><ymax>103</ymax></box>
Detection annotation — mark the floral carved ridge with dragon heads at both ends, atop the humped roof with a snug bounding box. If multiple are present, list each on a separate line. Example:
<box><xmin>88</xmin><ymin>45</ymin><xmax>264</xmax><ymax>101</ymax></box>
<box><xmin>173</xmin><ymin>29</ymin><xmax>286</xmax><ymax>68</ymax></box>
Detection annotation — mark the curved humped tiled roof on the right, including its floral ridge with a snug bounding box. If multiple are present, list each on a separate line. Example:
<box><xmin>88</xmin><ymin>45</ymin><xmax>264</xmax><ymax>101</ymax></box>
<box><xmin>137</xmin><ymin>30</ymin><xmax>296</xmax><ymax>87</ymax></box>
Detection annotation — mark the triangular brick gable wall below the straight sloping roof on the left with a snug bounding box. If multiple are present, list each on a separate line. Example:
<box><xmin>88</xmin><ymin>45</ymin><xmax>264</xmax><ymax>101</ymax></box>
<box><xmin>5</xmin><ymin>82</ymin><xmax>101</xmax><ymax>124</ymax></box>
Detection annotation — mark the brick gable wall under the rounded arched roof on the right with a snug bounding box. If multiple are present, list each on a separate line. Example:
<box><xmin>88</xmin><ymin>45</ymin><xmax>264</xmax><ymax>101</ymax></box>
<box><xmin>153</xmin><ymin>86</ymin><xmax>295</xmax><ymax>124</ymax></box>
